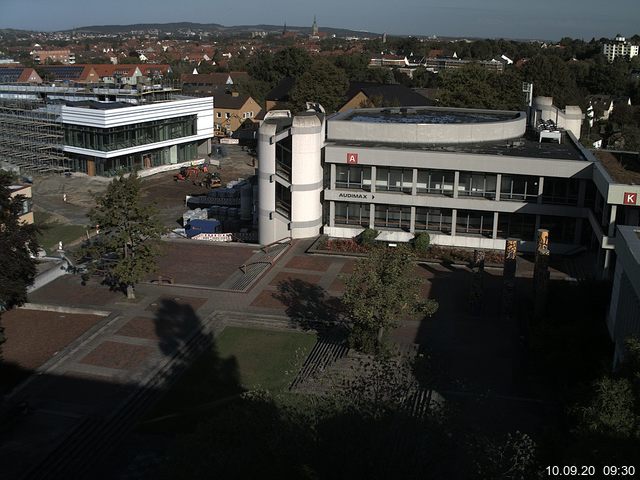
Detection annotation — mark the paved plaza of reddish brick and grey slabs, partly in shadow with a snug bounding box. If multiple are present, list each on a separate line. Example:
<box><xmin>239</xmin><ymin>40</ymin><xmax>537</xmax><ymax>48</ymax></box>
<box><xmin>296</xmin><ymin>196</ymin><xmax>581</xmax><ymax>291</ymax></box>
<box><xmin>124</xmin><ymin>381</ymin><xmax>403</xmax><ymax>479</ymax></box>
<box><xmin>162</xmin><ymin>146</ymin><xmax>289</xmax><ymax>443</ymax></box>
<box><xmin>0</xmin><ymin>241</ymin><xmax>568</xmax><ymax>479</ymax></box>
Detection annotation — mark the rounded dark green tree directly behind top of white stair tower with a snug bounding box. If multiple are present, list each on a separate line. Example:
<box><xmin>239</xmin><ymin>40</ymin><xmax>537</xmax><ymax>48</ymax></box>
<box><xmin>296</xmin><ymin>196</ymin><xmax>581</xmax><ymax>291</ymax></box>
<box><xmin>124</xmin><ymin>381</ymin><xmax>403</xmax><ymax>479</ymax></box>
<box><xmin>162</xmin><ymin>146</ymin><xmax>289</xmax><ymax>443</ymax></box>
<box><xmin>291</xmin><ymin>59</ymin><xmax>349</xmax><ymax>112</ymax></box>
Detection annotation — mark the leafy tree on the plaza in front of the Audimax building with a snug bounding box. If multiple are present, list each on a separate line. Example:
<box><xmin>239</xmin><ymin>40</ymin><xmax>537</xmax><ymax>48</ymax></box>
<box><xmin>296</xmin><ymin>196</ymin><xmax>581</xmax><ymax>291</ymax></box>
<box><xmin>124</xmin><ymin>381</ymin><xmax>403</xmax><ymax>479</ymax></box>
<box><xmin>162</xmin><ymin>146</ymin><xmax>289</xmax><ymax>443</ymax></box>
<box><xmin>342</xmin><ymin>246</ymin><xmax>438</xmax><ymax>353</ymax></box>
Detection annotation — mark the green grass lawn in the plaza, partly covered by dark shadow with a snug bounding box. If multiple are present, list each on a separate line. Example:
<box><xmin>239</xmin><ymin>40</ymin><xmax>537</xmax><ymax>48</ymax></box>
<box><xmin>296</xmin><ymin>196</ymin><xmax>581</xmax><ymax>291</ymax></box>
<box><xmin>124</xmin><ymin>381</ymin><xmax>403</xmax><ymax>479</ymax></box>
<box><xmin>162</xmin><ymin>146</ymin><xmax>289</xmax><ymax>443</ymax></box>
<box><xmin>141</xmin><ymin>327</ymin><xmax>316</xmax><ymax>433</ymax></box>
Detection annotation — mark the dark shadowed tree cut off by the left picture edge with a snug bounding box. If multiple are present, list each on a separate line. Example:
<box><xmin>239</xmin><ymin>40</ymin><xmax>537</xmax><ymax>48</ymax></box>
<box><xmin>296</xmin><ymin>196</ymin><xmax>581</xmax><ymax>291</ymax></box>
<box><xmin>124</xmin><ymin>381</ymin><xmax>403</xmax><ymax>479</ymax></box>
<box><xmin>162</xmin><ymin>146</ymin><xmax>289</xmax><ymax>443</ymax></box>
<box><xmin>0</xmin><ymin>170</ymin><xmax>39</xmax><ymax>356</ymax></box>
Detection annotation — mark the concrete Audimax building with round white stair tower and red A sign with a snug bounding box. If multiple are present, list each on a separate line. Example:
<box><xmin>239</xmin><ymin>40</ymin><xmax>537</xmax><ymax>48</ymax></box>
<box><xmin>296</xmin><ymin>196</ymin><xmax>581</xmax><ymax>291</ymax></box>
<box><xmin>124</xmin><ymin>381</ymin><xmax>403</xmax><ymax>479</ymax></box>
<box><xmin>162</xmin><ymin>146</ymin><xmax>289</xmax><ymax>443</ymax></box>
<box><xmin>258</xmin><ymin>98</ymin><xmax>640</xmax><ymax>276</ymax></box>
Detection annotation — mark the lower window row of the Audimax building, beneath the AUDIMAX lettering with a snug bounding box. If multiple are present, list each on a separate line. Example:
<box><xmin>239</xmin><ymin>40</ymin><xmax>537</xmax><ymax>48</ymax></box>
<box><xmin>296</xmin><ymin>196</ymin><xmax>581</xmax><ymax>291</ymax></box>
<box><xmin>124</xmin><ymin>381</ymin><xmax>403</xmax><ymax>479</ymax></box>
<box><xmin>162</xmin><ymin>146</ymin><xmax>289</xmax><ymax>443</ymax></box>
<box><xmin>334</xmin><ymin>202</ymin><xmax>576</xmax><ymax>243</ymax></box>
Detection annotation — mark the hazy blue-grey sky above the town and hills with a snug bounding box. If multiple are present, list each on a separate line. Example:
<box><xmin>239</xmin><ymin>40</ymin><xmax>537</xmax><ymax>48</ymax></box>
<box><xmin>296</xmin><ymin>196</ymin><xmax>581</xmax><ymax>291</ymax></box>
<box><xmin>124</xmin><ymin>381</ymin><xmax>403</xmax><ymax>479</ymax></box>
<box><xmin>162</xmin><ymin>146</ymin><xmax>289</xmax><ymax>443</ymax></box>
<box><xmin>0</xmin><ymin>0</ymin><xmax>640</xmax><ymax>40</ymax></box>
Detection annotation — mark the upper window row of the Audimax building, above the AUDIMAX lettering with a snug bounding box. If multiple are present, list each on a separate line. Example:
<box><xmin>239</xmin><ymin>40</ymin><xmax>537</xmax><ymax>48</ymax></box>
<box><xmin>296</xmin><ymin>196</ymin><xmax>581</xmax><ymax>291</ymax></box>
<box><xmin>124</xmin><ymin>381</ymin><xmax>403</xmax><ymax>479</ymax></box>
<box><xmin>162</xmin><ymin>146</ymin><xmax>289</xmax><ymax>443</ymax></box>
<box><xmin>335</xmin><ymin>165</ymin><xmax>579</xmax><ymax>205</ymax></box>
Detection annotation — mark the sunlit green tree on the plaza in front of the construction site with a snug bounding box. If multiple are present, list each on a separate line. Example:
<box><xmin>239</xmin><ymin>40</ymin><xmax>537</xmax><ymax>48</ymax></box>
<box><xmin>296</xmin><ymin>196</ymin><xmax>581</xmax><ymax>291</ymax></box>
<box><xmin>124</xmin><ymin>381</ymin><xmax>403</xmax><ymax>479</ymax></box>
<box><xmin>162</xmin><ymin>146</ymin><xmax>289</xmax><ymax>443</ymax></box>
<box><xmin>82</xmin><ymin>172</ymin><xmax>165</xmax><ymax>298</ymax></box>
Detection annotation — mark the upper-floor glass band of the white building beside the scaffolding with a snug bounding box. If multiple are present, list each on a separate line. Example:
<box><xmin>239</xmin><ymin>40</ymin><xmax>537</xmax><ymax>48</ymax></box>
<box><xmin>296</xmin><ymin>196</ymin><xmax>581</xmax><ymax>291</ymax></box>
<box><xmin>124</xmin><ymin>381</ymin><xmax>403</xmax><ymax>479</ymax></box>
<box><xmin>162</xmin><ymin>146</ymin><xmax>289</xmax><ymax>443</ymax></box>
<box><xmin>64</xmin><ymin>115</ymin><xmax>196</xmax><ymax>152</ymax></box>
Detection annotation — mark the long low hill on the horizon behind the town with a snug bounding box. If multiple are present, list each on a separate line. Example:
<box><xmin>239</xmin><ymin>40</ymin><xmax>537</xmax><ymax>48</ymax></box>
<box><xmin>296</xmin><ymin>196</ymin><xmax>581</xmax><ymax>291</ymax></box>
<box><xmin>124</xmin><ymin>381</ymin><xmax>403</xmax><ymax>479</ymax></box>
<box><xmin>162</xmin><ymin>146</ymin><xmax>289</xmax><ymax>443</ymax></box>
<box><xmin>66</xmin><ymin>22</ymin><xmax>380</xmax><ymax>37</ymax></box>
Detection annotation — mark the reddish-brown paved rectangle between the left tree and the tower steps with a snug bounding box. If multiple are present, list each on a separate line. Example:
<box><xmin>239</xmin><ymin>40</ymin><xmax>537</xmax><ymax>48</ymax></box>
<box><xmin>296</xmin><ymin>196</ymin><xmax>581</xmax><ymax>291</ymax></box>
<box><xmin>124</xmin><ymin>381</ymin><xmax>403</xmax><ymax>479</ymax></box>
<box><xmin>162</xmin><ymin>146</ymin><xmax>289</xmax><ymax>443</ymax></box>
<box><xmin>149</xmin><ymin>240</ymin><xmax>257</xmax><ymax>288</ymax></box>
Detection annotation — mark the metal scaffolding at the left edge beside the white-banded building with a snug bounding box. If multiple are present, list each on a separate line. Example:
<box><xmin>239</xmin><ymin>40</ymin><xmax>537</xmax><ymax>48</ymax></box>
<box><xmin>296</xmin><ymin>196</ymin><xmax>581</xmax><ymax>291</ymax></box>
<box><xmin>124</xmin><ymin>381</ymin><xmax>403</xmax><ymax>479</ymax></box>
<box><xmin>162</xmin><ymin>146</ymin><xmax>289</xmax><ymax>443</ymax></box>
<box><xmin>0</xmin><ymin>100</ymin><xmax>71</xmax><ymax>175</ymax></box>
